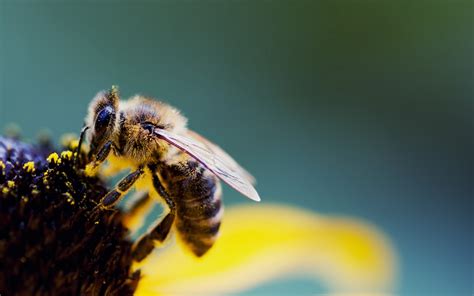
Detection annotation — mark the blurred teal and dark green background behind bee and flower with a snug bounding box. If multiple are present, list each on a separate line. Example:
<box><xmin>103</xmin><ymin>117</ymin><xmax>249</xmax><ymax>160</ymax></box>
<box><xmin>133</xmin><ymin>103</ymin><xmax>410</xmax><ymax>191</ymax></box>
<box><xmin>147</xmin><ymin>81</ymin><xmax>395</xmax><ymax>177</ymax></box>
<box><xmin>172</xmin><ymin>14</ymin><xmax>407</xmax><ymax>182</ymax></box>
<box><xmin>0</xmin><ymin>0</ymin><xmax>474</xmax><ymax>295</ymax></box>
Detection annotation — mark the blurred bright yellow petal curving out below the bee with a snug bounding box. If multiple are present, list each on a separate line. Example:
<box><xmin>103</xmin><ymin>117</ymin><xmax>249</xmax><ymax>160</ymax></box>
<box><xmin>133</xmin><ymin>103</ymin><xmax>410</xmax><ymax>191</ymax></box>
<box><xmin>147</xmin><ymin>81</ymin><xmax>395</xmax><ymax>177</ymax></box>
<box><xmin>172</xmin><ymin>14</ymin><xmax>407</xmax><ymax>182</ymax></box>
<box><xmin>136</xmin><ymin>204</ymin><xmax>396</xmax><ymax>295</ymax></box>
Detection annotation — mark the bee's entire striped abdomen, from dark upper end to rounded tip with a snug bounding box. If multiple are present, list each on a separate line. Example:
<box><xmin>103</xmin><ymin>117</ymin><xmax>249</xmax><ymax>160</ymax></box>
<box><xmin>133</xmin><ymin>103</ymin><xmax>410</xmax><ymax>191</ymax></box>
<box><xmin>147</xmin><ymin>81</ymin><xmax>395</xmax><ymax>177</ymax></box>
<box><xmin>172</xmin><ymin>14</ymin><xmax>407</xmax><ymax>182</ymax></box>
<box><xmin>161</xmin><ymin>159</ymin><xmax>223</xmax><ymax>256</ymax></box>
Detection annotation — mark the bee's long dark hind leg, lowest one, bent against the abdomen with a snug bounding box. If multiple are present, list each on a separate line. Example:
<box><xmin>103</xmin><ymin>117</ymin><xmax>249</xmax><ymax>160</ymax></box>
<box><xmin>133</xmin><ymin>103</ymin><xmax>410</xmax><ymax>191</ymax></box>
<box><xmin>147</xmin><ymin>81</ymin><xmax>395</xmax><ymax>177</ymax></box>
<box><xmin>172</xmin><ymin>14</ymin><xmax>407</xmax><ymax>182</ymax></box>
<box><xmin>132</xmin><ymin>166</ymin><xmax>176</xmax><ymax>261</ymax></box>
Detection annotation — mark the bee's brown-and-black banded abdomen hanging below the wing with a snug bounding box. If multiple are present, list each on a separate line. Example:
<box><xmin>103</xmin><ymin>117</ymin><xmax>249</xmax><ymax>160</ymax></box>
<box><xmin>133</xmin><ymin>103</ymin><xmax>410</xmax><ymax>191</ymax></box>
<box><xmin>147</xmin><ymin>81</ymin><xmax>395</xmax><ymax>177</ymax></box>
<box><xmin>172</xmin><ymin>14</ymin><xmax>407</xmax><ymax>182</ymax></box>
<box><xmin>176</xmin><ymin>166</ymin><xmax>223</xmax><ymax>256</ymax></box>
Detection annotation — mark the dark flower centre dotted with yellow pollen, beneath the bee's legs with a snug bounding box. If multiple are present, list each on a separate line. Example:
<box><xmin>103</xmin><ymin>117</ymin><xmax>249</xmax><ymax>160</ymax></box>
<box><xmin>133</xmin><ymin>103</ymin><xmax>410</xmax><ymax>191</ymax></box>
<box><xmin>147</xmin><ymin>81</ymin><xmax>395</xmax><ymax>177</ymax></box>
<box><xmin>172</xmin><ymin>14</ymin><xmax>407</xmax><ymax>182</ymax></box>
<box><xmin>0</xmin><ymin>137</ymin><xmax>140</xmax><ymax>295</ymax></box>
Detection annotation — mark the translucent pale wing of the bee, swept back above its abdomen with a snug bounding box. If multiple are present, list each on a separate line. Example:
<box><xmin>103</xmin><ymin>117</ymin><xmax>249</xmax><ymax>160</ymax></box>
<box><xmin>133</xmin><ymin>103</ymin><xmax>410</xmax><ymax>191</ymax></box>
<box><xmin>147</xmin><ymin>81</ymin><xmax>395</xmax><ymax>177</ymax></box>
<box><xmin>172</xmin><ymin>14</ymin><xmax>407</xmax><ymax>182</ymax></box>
<box><xmin>154</xmin><ymin>128</ymin><xmax>260</xmax><ymax>201</ymax></box>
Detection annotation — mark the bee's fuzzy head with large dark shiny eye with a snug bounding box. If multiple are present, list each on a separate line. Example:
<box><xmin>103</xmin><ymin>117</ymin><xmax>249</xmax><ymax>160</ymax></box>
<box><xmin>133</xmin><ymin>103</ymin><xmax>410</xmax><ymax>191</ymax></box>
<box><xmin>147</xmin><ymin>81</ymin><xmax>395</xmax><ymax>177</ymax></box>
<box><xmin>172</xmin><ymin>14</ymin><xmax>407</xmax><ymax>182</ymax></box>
<box><xmin>85</xmin><ymin>86</ymin><xmax>119</xmax><ymax>155</ymax></box>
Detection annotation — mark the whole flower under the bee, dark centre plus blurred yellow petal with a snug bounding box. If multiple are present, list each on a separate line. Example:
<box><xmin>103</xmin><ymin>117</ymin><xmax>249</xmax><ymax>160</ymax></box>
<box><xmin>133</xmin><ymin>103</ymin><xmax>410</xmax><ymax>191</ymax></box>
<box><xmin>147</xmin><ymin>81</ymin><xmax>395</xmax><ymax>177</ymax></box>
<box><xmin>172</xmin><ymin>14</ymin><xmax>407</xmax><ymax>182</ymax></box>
<box><xmin>0</xmin><ymin>137</ymin><xmax>396</xmax><ymax>295</ymax></box>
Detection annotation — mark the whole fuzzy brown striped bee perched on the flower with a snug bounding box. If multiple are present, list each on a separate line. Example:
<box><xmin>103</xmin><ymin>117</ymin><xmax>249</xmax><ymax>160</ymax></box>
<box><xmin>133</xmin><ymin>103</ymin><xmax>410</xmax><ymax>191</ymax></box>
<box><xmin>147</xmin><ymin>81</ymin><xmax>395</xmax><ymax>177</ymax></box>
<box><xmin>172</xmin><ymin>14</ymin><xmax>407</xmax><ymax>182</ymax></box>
<box><xmin>79</xmin><ymin>87</ymin><xmax>260</xmax><ymax>261</ymax></box>
